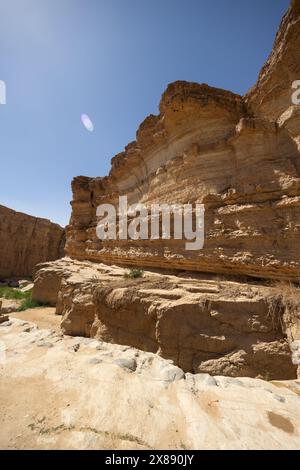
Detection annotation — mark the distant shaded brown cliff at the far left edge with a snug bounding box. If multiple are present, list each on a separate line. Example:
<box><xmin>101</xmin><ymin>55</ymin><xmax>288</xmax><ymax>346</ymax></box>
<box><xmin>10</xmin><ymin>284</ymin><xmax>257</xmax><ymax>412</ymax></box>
<box><xmin>0</xmin><ymin>206</ymin><xmax>65</xmax><ymax>279</ymax></box>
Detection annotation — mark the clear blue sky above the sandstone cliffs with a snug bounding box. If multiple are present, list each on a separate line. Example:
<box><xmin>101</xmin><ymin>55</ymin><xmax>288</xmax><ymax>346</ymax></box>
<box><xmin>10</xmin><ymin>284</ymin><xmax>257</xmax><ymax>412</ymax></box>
<box><xmin>0</xmin><ymin>0</ymin><xmax>289</xmax><ymax>225</ymax></box>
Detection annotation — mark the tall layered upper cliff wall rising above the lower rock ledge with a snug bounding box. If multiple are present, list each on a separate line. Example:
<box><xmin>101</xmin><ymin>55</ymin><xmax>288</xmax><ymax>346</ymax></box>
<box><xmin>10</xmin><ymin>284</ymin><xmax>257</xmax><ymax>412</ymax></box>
<box><xmin>66</xmin><ymin>1</ymin><xmax>300</xmax><ymax>280</ymax></box>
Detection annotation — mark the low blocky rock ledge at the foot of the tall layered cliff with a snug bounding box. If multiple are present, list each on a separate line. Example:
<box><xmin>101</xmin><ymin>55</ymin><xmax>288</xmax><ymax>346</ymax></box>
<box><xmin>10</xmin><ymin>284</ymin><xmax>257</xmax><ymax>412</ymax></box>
<box><xmin>33</xmin><ymin>258</ymin><xmax>297</xmax><ymax>379</ymax></box>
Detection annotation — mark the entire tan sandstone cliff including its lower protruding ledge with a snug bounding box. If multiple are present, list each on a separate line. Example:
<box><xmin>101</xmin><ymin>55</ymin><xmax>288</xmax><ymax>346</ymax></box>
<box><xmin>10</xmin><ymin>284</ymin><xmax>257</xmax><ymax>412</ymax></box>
<box><xmin>33</xmin><ymin>1</ymin><xmax>300</xmax><ymax>379</ymax></box>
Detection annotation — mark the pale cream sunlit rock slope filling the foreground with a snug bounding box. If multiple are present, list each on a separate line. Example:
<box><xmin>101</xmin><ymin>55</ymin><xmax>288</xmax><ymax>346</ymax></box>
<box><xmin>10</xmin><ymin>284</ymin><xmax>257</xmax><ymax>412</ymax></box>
<box><xmin>0</xmin><ymin>319</ymin><xmax>300</xmax><ymax>450</ymax></box>
